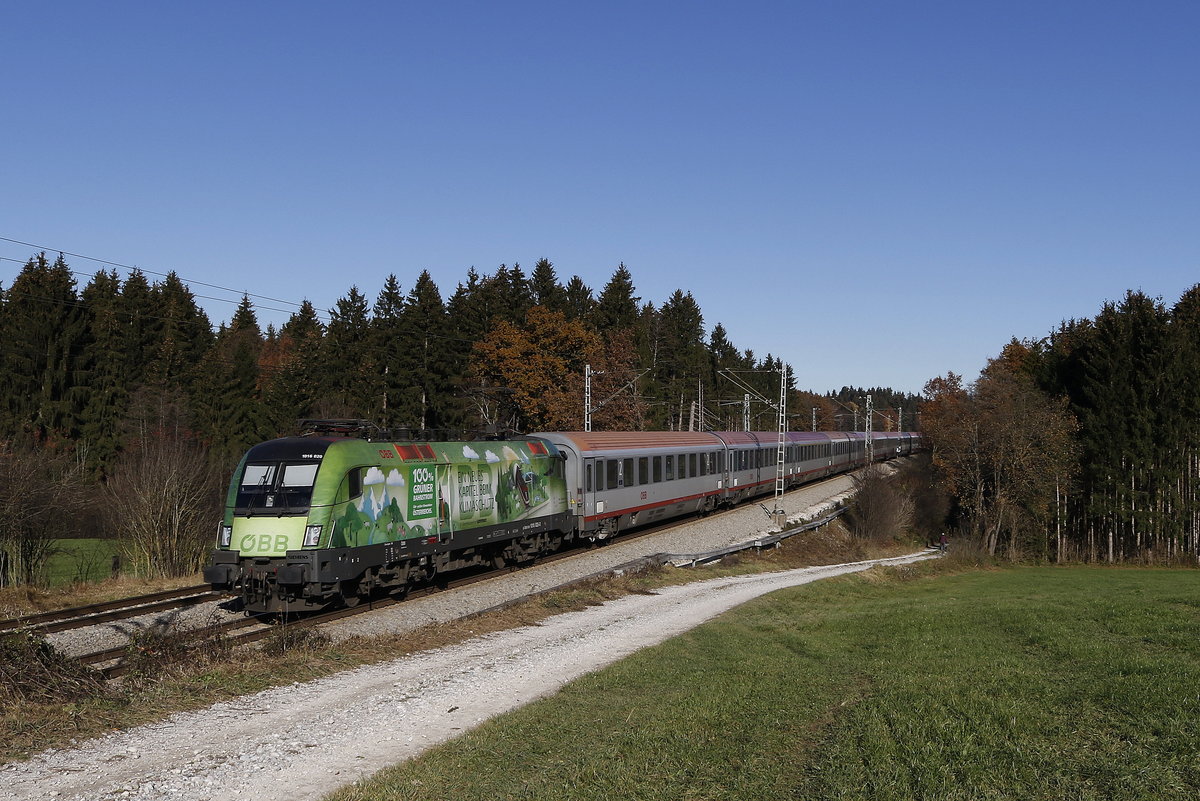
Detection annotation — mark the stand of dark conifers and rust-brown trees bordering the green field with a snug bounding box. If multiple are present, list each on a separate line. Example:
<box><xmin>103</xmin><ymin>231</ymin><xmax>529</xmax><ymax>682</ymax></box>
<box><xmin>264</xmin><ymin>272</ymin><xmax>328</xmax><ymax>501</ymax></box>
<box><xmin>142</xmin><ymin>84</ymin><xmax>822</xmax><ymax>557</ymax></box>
<box><xmin>920</xmin><ymin>285</ymin><xmax>1200</xmax><ymax>565</ymax></box>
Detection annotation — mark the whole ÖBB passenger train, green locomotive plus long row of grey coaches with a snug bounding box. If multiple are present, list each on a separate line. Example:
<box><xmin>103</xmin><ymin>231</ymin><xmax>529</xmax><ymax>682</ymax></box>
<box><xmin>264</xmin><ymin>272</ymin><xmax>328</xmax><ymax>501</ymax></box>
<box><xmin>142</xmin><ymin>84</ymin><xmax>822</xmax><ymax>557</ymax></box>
<box><xmin>204</xmin><ymin>426</ymin><xmax>920</xmax><ymax>614</ymax></box>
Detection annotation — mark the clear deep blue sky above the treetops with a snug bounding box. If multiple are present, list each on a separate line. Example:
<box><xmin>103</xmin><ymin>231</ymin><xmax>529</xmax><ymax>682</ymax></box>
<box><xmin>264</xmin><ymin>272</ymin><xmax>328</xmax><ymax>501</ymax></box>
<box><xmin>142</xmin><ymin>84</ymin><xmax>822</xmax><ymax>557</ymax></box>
<box><xmin>0</xmin><ymin>0</ymin><xmax>1200</xmax><ymax>392</ymax></box>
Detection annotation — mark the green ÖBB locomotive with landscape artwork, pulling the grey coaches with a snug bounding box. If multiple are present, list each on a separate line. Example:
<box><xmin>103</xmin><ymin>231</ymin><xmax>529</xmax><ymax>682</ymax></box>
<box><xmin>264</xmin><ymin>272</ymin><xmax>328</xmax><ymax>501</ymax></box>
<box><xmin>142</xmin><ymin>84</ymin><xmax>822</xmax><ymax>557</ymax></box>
<box><xmin>204</xmin><ymin>436</ymin><xmax>572</xmax><ymax>613</ymax></box>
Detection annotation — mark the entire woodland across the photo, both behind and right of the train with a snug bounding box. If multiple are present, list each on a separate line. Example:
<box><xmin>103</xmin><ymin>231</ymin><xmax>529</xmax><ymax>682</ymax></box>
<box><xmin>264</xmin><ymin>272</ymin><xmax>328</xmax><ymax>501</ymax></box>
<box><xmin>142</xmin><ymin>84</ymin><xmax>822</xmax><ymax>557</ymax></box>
<box><xmin>0</xmin><ymin>254</ymin><xmax>1200</xmax><ymax>584</ymax></box>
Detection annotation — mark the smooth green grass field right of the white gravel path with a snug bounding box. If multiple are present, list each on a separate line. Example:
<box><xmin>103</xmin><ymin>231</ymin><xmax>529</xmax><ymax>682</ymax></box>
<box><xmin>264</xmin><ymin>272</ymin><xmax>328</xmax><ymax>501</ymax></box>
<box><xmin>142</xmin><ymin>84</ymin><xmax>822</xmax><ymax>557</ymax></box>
<box><xmin>331</xmin><ymin>567</ymin><xmax>1200</xmax><ymax>801</ymax></box>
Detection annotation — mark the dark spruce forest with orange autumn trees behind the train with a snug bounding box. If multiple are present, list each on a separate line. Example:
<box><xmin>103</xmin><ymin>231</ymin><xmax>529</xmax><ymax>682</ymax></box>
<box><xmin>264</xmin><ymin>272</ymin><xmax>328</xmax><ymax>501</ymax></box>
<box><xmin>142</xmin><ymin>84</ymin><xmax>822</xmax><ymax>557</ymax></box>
<box><xmin>0</xmin><ymin>253</ymin><xmax>902</xmax><ymax>583</ymax></box>
